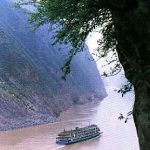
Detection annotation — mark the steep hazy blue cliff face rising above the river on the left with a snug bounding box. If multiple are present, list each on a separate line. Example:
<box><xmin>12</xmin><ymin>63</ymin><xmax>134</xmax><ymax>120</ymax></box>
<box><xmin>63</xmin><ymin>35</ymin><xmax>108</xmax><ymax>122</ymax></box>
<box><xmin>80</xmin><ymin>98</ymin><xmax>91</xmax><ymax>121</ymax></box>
<box><xmin>0</xmin><ymin>0</ymin><xmax>106</xmax><ymax>130</ymax></box>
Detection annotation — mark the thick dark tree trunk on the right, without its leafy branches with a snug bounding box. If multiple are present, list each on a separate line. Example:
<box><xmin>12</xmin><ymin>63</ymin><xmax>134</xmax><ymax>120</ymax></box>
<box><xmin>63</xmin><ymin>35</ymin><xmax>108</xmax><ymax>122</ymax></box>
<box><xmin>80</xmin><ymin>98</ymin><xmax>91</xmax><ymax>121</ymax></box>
<box><xmin>111</xmin><ymin>0</ymin><xmax>150</xmax><ymax>150</ymax></box>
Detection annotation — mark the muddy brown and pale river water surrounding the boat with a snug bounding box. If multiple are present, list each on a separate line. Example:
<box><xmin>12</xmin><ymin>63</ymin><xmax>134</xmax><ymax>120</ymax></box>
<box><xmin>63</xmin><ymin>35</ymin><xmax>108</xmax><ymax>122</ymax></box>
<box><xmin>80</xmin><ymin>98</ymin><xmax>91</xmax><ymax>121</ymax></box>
<box><xmin>0</xmin><ymin>87</ymin><xmax>138</xmax><ymax>150</ymax></box>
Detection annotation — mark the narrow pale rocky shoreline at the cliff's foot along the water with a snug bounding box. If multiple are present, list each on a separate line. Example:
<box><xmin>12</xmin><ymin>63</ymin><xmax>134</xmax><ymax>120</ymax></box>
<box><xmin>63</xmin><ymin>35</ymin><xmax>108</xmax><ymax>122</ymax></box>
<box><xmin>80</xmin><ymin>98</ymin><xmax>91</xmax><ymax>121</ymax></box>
<box><xmin>0</xmin><ymin>95</ymin><xmax>107</xmax><ymax>132</ymax></box>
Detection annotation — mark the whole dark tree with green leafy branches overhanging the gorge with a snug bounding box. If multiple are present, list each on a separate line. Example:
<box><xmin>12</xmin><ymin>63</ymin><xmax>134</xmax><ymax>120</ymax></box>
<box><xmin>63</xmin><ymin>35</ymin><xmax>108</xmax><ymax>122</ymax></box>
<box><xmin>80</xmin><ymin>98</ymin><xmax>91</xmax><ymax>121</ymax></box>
<box><xmin>17</xmin><ymin>0</ymin><xmax>150</xmax><ymax>150</ymax></box>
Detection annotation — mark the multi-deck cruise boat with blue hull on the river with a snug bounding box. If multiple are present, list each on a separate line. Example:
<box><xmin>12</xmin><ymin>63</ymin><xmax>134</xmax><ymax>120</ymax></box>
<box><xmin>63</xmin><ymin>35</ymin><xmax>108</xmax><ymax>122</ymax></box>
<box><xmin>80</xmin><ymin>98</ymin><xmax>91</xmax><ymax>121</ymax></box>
<box><xmin>56</xmin><ymin>124</ymin><xmax>102</xmax><ymax>145</ymax></box>
